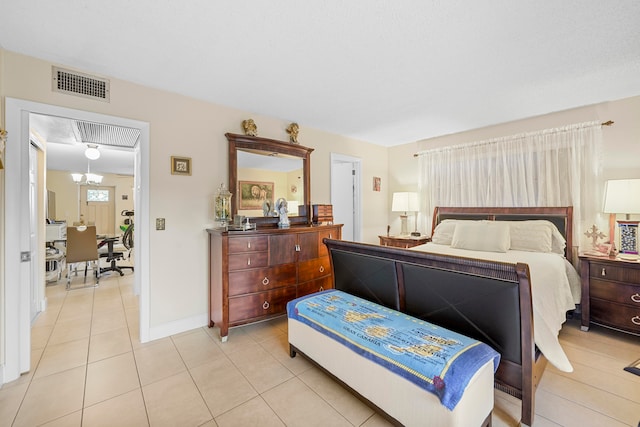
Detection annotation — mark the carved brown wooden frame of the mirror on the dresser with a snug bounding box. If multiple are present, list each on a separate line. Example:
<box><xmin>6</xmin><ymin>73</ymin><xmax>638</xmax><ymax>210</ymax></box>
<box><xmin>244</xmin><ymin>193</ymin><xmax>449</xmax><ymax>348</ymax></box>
<box><xmin>225</xmin><ymin>133</ymin><xmax>313</xmax><ymax>226</ymax></box>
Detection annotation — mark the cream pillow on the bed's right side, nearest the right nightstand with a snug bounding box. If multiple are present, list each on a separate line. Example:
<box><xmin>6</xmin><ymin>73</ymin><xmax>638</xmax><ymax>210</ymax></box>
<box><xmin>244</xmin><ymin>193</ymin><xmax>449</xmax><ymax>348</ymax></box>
<box><xmin>505</xmin><ymin>219</ymin><xmax>567</xmax><ymax>255</ymax></box>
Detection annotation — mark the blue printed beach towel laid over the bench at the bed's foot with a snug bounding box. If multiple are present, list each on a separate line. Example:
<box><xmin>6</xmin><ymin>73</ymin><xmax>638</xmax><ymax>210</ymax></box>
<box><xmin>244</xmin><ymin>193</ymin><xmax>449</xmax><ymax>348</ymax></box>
<box><xmin>287</xmin><ymin>290</ymin><xmax>500</xmax><ymax>410</ymax></box>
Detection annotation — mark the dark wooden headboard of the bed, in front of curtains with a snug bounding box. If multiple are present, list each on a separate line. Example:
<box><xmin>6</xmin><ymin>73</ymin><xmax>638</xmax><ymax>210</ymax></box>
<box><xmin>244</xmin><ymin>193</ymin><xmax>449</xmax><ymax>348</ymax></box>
<box><xmin>431</xmin><ymin>206</ymin><xmax>573</xmax><ymax>262</ymax></box>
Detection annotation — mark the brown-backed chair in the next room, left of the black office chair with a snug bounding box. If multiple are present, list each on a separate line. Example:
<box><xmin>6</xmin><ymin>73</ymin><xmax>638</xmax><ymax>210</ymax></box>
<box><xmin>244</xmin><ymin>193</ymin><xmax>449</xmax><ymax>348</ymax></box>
<box><xmin>66</xmin><ymin>225</ymin><xmax>100</xmax><ymax>290</ymax></box>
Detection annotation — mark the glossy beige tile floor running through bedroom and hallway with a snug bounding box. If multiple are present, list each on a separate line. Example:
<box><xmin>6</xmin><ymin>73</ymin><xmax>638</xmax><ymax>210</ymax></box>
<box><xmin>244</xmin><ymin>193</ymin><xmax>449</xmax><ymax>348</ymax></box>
<box><xmin>0</xmin><ymin>272</ymin><xmax>640</xmax><ymax>427</ymax></box>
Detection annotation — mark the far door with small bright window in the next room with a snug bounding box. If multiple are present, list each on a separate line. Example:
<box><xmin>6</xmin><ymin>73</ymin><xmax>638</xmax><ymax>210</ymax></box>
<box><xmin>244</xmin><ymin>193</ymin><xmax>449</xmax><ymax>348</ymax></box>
<box><xmin>80</xmin><ymin>185</ymin><xmax>115</xmax><ymax>236</ymax></box>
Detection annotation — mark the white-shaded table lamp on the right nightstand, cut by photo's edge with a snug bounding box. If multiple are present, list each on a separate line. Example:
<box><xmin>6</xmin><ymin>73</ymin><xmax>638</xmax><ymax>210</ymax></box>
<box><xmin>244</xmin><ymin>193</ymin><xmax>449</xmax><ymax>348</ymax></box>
<box><xmin>604</xmin><ymin>179</ymin><xmax>640</xmax><ymax>258</ymax></box>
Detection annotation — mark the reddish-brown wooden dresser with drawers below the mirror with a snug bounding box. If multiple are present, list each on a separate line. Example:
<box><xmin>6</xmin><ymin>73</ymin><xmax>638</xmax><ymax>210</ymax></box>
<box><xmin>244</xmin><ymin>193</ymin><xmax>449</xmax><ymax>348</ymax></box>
<box><xmin>208</xmin><ymin>224</ymin><xmax>342</xmax><ymax>341</ymax></box>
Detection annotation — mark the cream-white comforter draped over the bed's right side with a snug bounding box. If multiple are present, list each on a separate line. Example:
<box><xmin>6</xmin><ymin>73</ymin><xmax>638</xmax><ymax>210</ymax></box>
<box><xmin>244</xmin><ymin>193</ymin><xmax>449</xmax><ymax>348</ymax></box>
<box><xmin>411</xmin><ymin>243</ymin><xmax>579</xmax><ymax>372</ymax></box>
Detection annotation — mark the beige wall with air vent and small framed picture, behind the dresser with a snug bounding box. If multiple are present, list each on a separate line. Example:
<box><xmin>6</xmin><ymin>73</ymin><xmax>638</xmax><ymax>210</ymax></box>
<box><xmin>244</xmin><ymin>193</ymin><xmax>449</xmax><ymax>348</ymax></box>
<box><xmin>0</xmin><ymin>50</ymin><xmax>387</xmax><ymax>340</ymax></box>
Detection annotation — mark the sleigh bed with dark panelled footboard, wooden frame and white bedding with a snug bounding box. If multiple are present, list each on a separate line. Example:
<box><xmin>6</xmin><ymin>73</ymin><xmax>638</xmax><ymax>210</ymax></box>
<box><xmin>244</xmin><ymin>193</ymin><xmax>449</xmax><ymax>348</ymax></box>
<box><xmin>325</xmin><ymin>207</ymin><xmax>579</xmax><ymax>425</ymax></box>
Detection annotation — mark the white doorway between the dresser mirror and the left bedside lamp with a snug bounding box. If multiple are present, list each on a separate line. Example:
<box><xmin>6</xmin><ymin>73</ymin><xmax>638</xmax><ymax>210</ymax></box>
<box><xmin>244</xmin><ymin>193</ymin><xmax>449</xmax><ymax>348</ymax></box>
<box><xmin>331</xmin><ymin>153</ymin><xmax>362</xmax><ymax>242</ymax></box>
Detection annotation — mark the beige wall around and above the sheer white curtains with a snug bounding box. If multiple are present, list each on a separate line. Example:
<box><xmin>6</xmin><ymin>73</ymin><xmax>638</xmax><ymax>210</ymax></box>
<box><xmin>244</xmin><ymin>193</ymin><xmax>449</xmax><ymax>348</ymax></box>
<box><xmin>389</xmin><ymin>96</ymin><xmax>640</xmax><ymax>236</ymax></box>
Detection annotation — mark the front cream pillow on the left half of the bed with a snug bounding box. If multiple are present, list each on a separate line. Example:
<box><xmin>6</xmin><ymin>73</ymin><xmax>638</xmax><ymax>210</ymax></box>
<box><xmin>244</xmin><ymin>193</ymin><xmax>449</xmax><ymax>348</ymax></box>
<box><xmin>451</xmin><ymin>221</ymin><xmax>511</xmax><ymax>252</ymax></box>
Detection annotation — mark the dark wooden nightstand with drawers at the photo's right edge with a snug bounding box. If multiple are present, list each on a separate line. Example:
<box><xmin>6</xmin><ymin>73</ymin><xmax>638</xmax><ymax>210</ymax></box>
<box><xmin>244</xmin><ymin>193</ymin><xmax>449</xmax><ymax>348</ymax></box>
<box><xmin>580</xmin><ymin>255</ymin><xmax>640</xmax><ymax>335</ymax></box>
